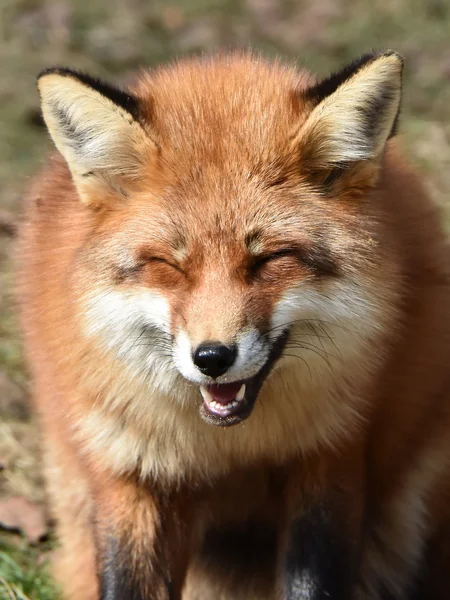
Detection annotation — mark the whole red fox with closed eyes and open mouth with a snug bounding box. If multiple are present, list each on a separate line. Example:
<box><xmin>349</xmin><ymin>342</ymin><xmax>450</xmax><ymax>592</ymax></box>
<box><xmin>15</xmin><ymin>51</ymin><xmax>450</xmax><ymax>600</ymax></box>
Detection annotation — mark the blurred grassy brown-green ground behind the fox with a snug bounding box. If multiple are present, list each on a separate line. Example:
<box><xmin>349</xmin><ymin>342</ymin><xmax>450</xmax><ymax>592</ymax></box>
<box><xmin>0</xmin><ymin>0</ymin><xmax>450</xmax><ymax>600</ymax></box>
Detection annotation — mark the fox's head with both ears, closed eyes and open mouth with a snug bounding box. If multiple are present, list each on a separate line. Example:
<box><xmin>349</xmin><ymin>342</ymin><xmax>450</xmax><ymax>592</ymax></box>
<box><xmin>39</xmin><ymin>52</ymin><xmax>402</xmax><ymax>425</ymax></box>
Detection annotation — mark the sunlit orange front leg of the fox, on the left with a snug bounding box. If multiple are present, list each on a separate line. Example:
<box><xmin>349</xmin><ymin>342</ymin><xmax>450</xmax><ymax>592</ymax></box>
<box><xmin>94</xmin><ymin>478</ymin><xmax>189</xmax><ymax>600</ymax></box>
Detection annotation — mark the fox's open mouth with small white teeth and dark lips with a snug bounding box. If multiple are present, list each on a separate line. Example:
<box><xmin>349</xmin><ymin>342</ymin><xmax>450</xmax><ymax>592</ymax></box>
<box><xmin>200</xmin><ymin>332</ymin><xmax>288</xmax><ymax>427</ymax></box>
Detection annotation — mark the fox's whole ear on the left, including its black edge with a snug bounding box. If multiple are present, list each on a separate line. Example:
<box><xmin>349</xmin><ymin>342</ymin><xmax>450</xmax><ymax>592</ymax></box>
<box><xmin>38</xmin><ymin>68</ymin><xmax>155</xmax><ymax>203</ymax></box>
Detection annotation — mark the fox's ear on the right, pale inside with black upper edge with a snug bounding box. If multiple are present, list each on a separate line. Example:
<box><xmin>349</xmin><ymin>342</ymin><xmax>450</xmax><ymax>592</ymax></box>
<box><xmin>297</xmin><ymin>52</ymin><xmax>403</xmax><ymax>176</ymax></box>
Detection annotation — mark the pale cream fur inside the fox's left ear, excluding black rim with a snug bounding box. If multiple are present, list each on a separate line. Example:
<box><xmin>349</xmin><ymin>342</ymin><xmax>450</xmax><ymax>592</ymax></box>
<box><xmin>39</xmin><ymin>73</ymin><xmax>151</xmax><ymax>195</ymax></box>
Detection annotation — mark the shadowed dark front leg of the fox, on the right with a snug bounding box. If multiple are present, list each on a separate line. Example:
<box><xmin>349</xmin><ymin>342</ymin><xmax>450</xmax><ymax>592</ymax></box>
<box><xmin>278</xmin><ymin>447</ymin><xmax>365</xmax><ymax>600</ymax></box>
